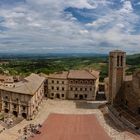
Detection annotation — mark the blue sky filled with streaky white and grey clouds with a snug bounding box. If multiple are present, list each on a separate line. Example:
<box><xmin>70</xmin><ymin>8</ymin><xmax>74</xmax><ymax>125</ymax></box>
<box><xmin>0</xmin><ymin>0</ymin><xmax>140</xmax><ymax>53</ymax></box>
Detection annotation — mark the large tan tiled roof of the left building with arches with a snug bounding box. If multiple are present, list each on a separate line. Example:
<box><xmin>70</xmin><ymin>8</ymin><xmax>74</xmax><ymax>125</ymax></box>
<box><xmin>0</xmin><ymin>74</ymin><xmax>45</xmax><ymax>95</ymax></box>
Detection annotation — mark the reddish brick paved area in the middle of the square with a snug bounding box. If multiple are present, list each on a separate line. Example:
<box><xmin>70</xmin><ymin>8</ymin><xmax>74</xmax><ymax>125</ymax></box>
<box><xmin>30</xmin><ymin>114</ymin><xmax>111</xmax><ymax>140</ymax></box>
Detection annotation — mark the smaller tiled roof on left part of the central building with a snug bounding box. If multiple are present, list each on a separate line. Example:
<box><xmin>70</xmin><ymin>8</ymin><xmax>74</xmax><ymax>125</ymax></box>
<box><xmin>49</xmin><ymin>71</ymin><xmax>68</xmax><ymax>79</ymax></box>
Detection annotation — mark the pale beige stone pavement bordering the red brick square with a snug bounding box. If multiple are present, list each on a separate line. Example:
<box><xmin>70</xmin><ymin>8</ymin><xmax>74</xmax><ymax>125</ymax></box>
<box><xmin>0</xmin><ymin>99</ymin><xmax>138</xmax><ymax>140</ymax></box>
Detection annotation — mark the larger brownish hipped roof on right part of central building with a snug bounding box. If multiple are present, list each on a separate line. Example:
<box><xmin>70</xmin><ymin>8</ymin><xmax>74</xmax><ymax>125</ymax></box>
<box><xmin>68</xmin><ymin>70</ymin><xmax>98</xmax><ymax>79</ymax></box>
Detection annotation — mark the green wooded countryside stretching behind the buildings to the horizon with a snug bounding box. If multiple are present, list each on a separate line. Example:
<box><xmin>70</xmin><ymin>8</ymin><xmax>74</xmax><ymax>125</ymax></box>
<box><xmin>0</xmin><ymin>55</ymin><xmax>140</xmax><ymax>81</ymax></box>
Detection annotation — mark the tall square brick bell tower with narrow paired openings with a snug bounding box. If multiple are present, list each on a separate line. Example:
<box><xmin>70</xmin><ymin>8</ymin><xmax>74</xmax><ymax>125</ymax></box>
<box><xmin>109</xmin><ymin>50</ymin><xmax>126</xmax><ymax>105</ymax></box>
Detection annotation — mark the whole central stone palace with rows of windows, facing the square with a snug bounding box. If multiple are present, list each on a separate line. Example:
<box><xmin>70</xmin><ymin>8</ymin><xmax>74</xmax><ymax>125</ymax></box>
<box><xmin>48</xmin><ymin>70</ymin><xmax>99</xmax><ymax>100</ymax></box>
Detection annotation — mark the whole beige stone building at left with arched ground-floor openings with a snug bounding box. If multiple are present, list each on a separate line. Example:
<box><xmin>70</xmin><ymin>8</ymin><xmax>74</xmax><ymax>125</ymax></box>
<box><xmin>0</xmin><ymin>74</ymin><xmax>45</xmax><ymax>120</ymax></box>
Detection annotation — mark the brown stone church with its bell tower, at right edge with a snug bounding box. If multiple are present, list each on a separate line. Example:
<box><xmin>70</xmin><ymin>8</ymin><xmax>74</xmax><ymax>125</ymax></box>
<box><xmin>105</xmin><ymin>51</ymin><xmax>140</xmax><ymax>114</ymax></box>
